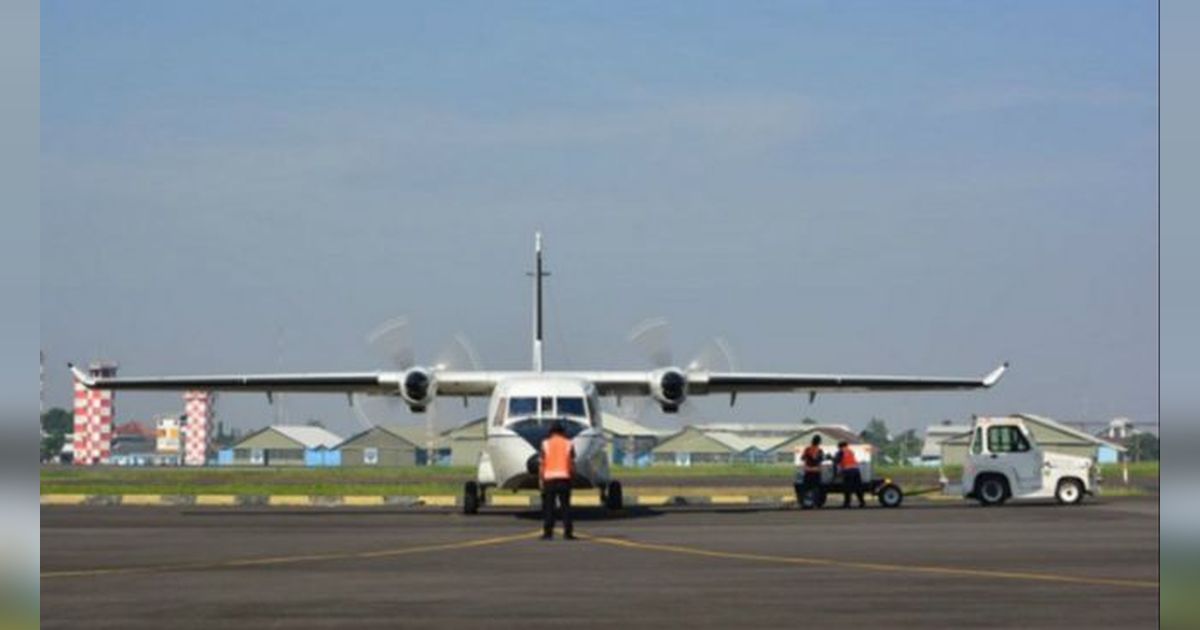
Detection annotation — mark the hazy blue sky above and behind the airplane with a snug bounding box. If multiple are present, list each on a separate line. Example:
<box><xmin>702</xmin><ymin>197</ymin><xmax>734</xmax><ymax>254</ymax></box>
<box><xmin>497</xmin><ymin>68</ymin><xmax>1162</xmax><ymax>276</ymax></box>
<box><xmin>41</xmin><ymin>1</ymin><xmax>1158</xmax><ymax>430</ymax></box>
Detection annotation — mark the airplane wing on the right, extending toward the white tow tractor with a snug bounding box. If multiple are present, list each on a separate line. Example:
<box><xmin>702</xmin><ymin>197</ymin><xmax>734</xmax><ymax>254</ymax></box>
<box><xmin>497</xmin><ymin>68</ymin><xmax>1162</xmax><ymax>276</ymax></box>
<box><xmin>580</xmin><ymin>362</ymin><xmax>1008</xmax><ymax>396</ymax></box>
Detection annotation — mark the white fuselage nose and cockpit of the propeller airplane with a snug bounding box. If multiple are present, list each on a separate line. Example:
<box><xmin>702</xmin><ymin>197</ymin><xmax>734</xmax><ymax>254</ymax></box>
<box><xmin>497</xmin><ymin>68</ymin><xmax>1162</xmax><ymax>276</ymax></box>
<box><xmin>478</xmin><ymin>373</ymin><xmax>610</xmax><ymax>490</ymax></box>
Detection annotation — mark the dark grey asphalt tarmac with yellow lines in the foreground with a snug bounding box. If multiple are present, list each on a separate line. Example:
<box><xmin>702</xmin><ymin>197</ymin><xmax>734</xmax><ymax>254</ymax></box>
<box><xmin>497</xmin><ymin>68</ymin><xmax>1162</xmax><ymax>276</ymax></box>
<box><xmin>41</xmin><ymin>498</ymin><xmax>1158</xmax><ymax>629</ymax></box>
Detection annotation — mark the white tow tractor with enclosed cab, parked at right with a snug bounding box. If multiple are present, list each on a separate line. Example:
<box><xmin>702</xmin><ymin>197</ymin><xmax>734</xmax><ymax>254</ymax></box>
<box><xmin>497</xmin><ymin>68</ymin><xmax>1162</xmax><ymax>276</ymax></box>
<box><xmin>962</xmin><ymin>418</ymin><xmax>1099</xmax><ymax>505</ymax></box>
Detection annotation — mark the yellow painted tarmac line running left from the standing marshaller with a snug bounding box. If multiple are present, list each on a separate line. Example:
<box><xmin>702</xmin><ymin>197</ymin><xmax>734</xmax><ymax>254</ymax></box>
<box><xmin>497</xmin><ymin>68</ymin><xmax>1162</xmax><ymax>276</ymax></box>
<box><xmin>41</xmin><ymin>529</ymin><xmax>541</xmax><ymax>580</ymax></box>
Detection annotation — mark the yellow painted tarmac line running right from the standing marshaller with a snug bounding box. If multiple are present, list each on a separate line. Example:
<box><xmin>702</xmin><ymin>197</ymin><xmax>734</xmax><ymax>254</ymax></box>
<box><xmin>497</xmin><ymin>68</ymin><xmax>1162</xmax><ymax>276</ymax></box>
<box><xmin>578</xmin><ymin>534</ymin><xmax>1158</xmax><ymax>588</ymax></box>
